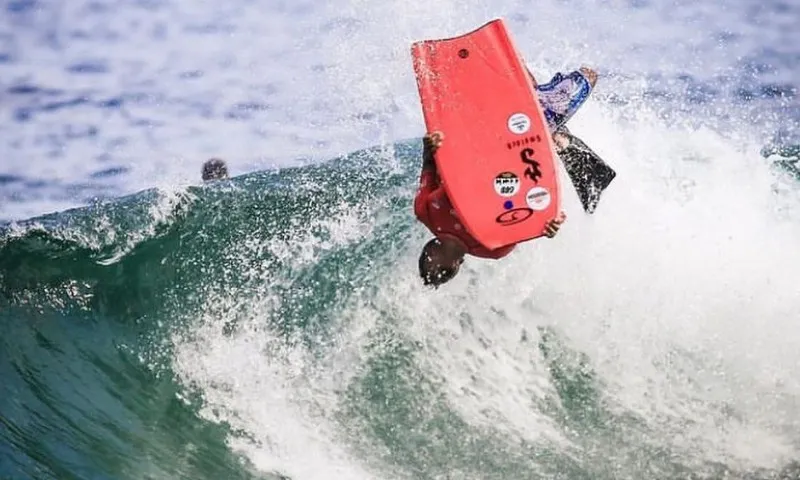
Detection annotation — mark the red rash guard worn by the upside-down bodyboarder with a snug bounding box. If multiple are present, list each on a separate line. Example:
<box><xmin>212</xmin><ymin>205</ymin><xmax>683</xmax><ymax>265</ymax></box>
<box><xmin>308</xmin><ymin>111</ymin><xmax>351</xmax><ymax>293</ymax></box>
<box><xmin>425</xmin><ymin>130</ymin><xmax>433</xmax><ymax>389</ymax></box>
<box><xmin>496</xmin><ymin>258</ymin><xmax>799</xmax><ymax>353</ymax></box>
<box><xmin>414</xmin><ymin>168</ymin><xmax>514</xmax><ymax>259</ymax></box>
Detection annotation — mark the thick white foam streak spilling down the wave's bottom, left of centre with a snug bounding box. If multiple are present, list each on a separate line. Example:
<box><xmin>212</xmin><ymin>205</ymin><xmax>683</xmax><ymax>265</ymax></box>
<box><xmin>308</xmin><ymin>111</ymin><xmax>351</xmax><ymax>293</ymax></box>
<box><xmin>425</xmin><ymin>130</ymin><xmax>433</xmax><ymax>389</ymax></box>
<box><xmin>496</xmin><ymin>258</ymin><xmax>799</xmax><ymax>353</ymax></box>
<box><xmin>175</xmin><ymin>312</ymin><xmax>371</xmax><ymax>479</ymax></box>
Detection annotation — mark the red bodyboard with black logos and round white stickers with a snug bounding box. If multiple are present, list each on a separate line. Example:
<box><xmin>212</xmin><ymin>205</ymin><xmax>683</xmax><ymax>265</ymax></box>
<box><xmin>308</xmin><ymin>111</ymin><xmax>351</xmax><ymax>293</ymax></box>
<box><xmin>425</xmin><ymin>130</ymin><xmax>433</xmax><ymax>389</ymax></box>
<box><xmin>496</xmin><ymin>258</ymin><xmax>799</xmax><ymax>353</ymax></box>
<box><xmin>411</xmin><ymin>19</ymin><xmax>560</xmax><ymax>249</ymax></box>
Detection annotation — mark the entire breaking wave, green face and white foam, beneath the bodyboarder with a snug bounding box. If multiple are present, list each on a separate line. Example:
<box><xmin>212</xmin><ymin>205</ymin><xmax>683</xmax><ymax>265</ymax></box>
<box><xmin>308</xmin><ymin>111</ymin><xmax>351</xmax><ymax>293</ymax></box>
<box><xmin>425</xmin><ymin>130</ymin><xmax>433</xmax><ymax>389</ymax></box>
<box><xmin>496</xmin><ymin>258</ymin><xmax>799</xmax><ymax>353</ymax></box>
<box><xmin>0</xmin><ymin>132</ymin><xmax>800</xmax><ymax>479</ymax></box>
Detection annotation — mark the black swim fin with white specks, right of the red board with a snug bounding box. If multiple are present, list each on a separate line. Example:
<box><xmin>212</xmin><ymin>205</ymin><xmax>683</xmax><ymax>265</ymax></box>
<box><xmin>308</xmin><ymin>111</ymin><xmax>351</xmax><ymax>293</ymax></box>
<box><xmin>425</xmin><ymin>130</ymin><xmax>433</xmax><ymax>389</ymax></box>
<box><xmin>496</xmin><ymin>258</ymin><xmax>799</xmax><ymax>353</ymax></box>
<box><xmin>557</xmin><ymin>127</ymin><xmax>617</xmax><ymax>213</ymax></box>
